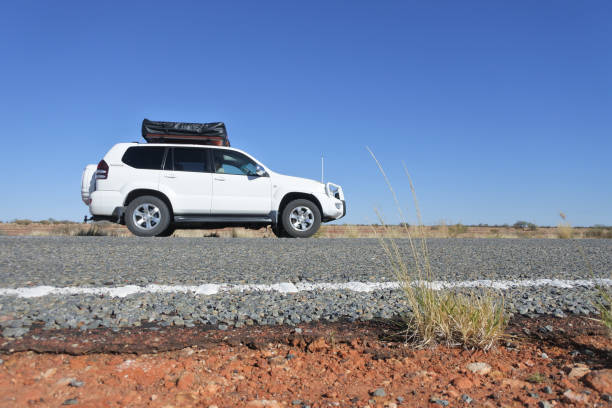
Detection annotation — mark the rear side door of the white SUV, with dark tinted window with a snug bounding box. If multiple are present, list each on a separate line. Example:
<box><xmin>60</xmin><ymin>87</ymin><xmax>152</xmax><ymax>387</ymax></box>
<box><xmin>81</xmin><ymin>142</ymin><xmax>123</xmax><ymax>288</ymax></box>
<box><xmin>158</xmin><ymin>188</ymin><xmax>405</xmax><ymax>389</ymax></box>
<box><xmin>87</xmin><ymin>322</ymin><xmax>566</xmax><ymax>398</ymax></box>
<box><xmin>160</xmin><ymin>147</ymin><xmax>212</xmax><ymax>214</ymax></box>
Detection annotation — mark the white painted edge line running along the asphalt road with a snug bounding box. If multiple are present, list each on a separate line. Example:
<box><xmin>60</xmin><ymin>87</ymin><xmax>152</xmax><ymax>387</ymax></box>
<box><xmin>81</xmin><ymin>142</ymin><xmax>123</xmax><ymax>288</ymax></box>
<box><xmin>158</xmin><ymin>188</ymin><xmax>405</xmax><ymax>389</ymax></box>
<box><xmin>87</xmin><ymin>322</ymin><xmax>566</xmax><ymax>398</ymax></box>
<box><xmin>0</xmin><ymin>279</ymin><xmax>612</xmax><ymax>298</ymax></box>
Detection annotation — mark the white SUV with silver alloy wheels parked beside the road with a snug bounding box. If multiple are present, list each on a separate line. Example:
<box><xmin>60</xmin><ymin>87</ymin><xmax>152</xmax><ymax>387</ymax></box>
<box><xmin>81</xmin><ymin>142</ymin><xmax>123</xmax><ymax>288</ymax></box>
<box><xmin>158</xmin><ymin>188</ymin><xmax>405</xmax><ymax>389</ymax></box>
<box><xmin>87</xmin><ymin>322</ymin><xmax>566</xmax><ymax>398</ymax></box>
<box><xmin>81</xmin><ymin>143</ymin><xmax>346</xmax><ymax>238</ymax></box>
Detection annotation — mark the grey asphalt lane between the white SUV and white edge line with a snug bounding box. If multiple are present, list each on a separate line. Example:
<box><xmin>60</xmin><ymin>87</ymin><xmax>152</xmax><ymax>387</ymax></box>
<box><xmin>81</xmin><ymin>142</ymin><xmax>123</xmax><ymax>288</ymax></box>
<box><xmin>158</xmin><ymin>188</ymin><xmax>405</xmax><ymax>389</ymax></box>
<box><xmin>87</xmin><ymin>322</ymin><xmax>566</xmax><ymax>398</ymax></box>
<box><xmin>0</xmin><ymin>237</ymin><xmax>612</xmax><ymax>287</ymax></box>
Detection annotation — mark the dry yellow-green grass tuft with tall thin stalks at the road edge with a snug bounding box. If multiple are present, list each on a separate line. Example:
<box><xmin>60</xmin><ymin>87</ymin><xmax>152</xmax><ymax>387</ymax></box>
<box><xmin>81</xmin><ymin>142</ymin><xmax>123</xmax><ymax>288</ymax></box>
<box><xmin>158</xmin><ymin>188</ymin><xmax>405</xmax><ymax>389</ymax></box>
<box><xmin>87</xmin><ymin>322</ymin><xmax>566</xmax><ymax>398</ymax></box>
<box><xmin>368</xmin><ymin>148</ymin><xmax>508</xmax><ymax>350</ymax></box>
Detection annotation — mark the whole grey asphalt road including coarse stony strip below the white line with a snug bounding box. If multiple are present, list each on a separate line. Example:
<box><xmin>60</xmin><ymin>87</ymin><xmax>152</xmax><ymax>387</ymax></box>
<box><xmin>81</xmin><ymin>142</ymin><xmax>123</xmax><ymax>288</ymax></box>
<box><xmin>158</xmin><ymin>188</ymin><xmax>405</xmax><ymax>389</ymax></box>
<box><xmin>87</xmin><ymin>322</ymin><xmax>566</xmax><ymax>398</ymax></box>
<box><xmin>0</xmin><ymin>237</ymin><xmax>612</xmax><ymax>338</ymax></box>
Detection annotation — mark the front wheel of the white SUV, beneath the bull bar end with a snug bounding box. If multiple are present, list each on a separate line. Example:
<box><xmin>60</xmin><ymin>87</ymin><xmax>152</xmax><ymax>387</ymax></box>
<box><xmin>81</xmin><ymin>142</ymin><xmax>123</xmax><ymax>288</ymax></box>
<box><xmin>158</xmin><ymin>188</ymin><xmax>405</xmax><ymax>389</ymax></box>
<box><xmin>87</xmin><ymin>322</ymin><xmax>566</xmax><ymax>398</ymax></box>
<box><xmin>281</xmin><ymin>199</ymin><xmax>321</xmax><ymax>238</ymax></box>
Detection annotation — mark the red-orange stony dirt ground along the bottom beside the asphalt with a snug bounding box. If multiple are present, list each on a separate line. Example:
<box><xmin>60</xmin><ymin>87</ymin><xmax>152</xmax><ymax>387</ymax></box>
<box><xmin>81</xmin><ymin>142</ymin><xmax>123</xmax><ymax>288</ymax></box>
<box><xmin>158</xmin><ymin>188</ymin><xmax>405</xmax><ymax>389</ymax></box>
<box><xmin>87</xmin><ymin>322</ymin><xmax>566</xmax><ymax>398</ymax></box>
<box><xmin>0</xmin><ymin>318</ymin><xmax>612</xmax><ymax>408</ymax></box>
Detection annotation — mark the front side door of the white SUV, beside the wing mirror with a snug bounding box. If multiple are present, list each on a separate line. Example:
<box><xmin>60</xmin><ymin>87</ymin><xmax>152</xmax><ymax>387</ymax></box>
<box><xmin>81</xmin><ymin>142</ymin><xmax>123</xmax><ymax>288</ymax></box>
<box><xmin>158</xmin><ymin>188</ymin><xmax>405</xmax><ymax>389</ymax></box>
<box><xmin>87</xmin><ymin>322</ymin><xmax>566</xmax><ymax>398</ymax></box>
<box><xmin>210</xmin><ymin>149</ymin><xmax>272</xmax><ymax>215</ymax></box>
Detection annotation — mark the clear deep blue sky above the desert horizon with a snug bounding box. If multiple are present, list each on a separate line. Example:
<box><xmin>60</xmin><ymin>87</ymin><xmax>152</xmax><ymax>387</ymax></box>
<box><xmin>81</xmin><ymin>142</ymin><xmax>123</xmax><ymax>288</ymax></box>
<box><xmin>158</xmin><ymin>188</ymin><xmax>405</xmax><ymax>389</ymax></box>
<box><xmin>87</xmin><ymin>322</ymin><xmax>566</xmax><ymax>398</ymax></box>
<box><xmin>0</xmin><ymin>1</ymin><xmax>612</xmax><ymax>225</ymax></box>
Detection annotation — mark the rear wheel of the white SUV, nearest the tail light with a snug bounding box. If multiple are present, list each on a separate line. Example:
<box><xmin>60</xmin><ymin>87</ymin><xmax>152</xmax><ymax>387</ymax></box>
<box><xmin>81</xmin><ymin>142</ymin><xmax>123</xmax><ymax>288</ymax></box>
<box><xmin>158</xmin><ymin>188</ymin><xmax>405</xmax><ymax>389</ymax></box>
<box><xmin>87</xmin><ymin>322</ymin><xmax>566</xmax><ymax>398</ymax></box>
<box><xmin>125</xmin><ymin>196</ymin><xmax>171</xmax><ymax>237</ymax></box>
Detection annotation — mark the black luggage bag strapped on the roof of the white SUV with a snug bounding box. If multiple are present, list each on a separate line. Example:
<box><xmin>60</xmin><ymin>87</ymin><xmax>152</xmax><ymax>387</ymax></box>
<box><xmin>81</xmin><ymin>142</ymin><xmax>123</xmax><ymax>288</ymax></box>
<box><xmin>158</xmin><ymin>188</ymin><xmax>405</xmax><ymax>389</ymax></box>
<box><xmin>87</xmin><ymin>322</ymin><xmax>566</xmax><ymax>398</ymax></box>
<box><xmin>142</xmin><ymin>119</ymin><xmax>230</xmax><ymax>146</ymax></box>
